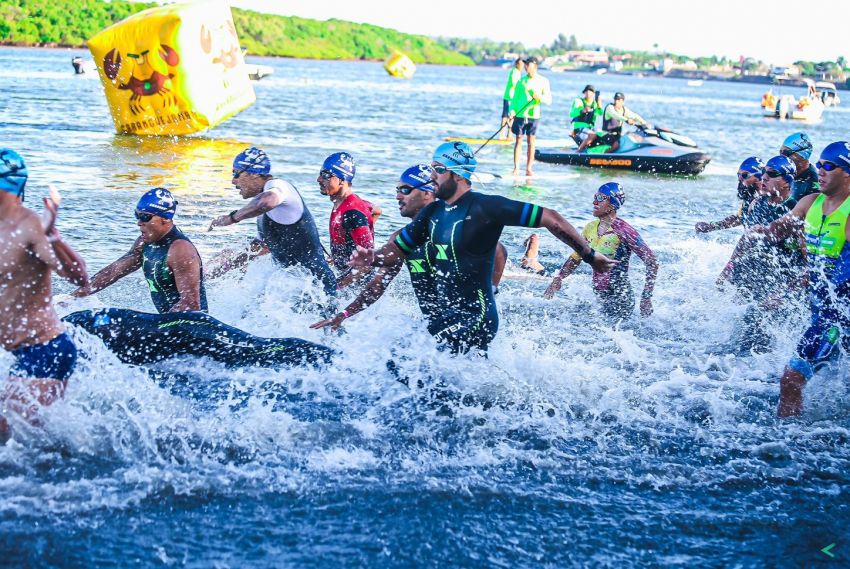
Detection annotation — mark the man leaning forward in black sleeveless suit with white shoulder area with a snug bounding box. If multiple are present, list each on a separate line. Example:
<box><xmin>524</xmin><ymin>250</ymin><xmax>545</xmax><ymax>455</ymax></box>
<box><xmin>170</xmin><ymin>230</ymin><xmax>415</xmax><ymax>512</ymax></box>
<box><xmin>209</xmin><ymin>147</ymin><xmax>336</xmax><ymax>294</ymax></box>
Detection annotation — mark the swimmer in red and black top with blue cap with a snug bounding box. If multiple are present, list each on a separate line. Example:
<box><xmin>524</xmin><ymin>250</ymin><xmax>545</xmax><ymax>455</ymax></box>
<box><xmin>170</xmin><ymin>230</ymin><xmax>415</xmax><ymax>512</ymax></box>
<box><xmin>316</xmin><ymin>152</ymin><xmax>375</xmax><ymax>289</ymax></box>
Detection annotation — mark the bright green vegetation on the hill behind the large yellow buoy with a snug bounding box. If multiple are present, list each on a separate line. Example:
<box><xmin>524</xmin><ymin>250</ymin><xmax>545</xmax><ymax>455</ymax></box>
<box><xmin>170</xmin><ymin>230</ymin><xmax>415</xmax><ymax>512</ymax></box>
<box><xmin>0</xmin><ymin>0</ymin><xmax>473</xmax><ymax>65</ymax></box>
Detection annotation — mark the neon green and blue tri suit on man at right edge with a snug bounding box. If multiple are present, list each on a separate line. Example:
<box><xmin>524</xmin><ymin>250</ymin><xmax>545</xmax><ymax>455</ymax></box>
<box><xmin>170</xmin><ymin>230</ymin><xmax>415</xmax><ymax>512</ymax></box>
<box><xmin>788</xmin><ymin>195</ymin><xmax>850</xmax><ymax>379</ymax></box>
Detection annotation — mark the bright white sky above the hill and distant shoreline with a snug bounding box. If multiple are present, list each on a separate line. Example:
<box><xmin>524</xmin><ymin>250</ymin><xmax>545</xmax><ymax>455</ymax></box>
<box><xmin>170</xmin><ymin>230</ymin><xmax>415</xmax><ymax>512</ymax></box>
<box><xmin>232</xmin><ymin>0</ymin><xmax>850</xmax><ymax>65</ymax></box>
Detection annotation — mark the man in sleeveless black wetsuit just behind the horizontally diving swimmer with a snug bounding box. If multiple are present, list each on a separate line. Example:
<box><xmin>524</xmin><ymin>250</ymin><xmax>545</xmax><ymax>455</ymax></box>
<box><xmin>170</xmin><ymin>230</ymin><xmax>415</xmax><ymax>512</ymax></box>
<box><xmin>71</xmin><ymin>188</ymin><xmax>207</xmax><ymax>313</ymax></box>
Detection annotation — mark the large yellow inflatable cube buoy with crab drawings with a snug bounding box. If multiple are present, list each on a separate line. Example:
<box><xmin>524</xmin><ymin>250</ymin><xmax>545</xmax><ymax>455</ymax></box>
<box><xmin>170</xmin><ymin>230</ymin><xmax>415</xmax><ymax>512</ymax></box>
<box><xmin>88</xmin><ymin>2</ymin><xmax>256</xmax><ymax>135</ymax></box>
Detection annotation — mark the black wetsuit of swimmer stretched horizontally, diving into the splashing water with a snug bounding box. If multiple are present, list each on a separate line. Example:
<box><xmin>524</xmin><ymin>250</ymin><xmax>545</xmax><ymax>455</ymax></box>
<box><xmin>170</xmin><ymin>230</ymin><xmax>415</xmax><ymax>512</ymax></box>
<box><xmin>62</xmin><ymin>308</ymin><xmax>334</xmax><ymax>368</ymax></box>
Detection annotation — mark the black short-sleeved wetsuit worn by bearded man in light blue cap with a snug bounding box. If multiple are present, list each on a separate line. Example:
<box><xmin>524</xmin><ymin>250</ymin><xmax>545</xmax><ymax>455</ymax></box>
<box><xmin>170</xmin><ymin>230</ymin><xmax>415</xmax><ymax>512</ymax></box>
<box><xmin>395</xmin><ymin>192</ymin><xmax>543</xmax><ymax>352</ymax></box>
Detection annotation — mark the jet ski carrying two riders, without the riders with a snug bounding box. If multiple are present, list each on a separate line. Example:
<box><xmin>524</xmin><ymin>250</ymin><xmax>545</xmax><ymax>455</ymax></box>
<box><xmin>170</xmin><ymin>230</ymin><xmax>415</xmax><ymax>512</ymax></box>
<box><xmin>534</xmin><ymin>127</ymin><xmax>711</xmax><ymax>174</ymax></box>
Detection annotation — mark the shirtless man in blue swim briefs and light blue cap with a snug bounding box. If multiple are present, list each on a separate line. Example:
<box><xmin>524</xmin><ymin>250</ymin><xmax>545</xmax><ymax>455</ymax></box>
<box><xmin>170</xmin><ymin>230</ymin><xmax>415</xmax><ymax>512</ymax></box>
<box><xmin>0</xmin><ymin>148</ymin><xmax>88</xmax><ymax>444</ymax></box>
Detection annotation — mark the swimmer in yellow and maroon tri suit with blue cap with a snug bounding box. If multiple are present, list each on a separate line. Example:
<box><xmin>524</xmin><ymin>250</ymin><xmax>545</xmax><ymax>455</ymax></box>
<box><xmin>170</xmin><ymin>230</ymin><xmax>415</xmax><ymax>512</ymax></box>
<box><xmin>543</xmin><ymin>182</ymin><xmax>658</xmax><ymax>320</ymax></box>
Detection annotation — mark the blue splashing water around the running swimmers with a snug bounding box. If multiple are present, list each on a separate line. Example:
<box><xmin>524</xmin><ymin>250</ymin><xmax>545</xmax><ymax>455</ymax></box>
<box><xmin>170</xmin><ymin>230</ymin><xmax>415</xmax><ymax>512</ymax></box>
<box><xmin>0</xmin><ymin>49</ymin><xmax>850</xmax><ymax>567</ymax></box>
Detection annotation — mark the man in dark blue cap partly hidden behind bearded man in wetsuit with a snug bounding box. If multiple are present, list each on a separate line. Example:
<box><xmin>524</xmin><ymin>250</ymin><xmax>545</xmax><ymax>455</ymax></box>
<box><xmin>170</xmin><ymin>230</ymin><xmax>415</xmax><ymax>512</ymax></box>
<box><xmin>310</xmin><ymin>164</ymin><xmax>508</xmax><ymax>330</ymax></box>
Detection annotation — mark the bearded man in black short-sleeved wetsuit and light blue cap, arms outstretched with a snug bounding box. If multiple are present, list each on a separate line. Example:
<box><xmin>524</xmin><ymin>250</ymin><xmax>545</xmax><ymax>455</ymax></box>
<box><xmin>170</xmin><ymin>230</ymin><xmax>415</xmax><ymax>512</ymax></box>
<box><xmin>351</xmin><ymin>142</ymin><xmax>615</xmax><ymax>353</ymax></box>
